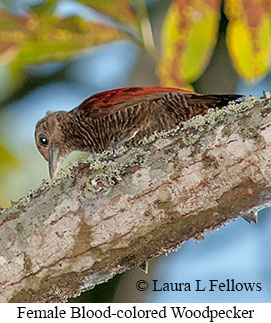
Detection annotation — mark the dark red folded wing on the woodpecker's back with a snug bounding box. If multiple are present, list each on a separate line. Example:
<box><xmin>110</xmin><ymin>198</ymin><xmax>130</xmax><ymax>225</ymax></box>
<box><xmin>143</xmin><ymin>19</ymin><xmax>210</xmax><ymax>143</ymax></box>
<box><xmin>73</xmin><ymin>86</ymin><xmax>191</xmax><ymax>117</ymax></box>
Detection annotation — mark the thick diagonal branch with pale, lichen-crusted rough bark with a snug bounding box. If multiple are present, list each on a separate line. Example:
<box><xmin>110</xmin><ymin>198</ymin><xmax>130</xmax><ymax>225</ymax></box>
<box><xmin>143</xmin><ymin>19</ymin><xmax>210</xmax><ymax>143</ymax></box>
<box><xmin>0</xmin><ymin>93</ymin><xmax>271</xmax><ymax>302</ymax></box>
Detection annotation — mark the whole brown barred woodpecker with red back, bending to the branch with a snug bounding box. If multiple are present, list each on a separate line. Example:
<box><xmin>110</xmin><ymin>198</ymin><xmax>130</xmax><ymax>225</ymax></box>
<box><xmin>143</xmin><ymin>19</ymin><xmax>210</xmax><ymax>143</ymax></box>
<box><xmin>35</xmin><ymin>87</ymin><xmax>242</xmax><ymax>179</ymax></box>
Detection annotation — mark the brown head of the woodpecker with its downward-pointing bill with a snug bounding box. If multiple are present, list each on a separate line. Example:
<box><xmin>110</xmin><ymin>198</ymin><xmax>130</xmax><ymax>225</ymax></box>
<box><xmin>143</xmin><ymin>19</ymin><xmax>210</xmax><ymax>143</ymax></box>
<box><xmin>35</xmin><ymin>111</ymin><xmax>73</xmax><ymax>179</ymax></box>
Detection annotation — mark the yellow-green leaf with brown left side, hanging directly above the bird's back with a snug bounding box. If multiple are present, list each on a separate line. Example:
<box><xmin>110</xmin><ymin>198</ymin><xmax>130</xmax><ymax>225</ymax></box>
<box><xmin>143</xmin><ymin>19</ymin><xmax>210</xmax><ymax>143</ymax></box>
<box><xmin>159</xmin><ymin>0</ymin><xmax>220</xmax><ymax>86</ymax></box>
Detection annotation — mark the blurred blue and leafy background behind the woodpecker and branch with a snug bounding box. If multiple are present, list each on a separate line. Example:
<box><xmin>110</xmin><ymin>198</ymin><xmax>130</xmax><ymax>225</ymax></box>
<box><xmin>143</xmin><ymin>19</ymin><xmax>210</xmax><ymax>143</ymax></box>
<box><xmin>0</xmin><ymin>0</ymin><xmax>271</xmax><ymax>302</ymax></box>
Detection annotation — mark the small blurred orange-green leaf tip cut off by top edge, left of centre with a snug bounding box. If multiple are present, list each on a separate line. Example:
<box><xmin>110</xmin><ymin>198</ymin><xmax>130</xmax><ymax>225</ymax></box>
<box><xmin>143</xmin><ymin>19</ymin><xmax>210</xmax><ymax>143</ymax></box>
<box><xmin>78</xmin><ymin>0</ymin><xmax>137</xmax><ymax>27</ymax></box>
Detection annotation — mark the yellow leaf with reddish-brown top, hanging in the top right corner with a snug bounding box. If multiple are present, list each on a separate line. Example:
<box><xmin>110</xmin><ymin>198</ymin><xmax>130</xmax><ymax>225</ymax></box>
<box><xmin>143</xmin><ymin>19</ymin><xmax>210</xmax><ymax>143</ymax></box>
<box><xmin>224</xmin><ymin>0</ymin><xmax>271</xmax><ymax>82</ymax></box>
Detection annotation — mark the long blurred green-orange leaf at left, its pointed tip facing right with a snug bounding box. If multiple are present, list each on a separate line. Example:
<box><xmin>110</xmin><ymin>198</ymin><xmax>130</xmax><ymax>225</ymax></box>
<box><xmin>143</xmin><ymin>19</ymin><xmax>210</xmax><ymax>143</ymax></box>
<box><xmin>0</xmin><ymin>12</ymin><xmax>127</xmax><ymax>66</ymax></box>
